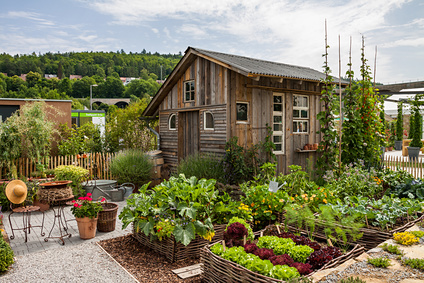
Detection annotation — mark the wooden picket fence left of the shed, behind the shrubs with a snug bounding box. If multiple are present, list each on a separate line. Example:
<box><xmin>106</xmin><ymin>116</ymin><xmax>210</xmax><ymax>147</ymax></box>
<box><xmin>0</xmin><ymin>153</ymin><xmax>115</xmax><ymax>180</ymax></box>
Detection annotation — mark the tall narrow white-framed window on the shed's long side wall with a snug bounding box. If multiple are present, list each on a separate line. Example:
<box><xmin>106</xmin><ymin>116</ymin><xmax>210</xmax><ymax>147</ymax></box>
<box><xmin>272</xmin><ymin>93</ymin><xmax>284</xmax><ymax>154</ymax></box>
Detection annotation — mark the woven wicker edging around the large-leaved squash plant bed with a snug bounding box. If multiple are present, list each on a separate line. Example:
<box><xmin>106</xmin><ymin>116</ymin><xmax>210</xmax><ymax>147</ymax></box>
<box><xmin>133</xmin><ymin>224</ymin><xmax>226</xmax><ymax>262</ymax></box>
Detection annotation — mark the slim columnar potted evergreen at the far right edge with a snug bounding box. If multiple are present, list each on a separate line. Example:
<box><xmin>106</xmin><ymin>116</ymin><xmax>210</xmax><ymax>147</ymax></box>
<box><xmin>408</xmin><ymin>95</ymin><xmax>423</xmax><ymax>161</ymax></box>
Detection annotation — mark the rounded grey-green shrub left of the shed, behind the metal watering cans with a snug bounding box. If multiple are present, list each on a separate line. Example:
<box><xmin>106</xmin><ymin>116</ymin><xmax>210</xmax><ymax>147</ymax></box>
<box><xmin>110</xmin><ymin>149</ymin><xmax>153</xmax><ymax>186</ymax></box>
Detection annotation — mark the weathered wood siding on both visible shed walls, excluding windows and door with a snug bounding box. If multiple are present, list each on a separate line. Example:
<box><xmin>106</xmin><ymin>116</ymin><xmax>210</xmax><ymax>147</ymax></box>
<box><xmin>159</xmin><ymin>57</ymin><xmax>321</xmax><ymax>174</ymax></box>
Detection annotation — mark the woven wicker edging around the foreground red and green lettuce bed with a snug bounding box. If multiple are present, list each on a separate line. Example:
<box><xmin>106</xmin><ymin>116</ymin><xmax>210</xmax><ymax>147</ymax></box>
<box><xmin>201</xmin><ymin>242</ymin><xmax>365</xmax><ymax>283</ymax></box>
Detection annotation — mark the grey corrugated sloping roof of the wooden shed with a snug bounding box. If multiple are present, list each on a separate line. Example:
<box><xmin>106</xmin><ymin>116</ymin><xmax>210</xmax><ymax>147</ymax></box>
<box><xmin>189</xmin><ymin>47</ymin><xmax>325</xmax><ymax>81</ymax></box>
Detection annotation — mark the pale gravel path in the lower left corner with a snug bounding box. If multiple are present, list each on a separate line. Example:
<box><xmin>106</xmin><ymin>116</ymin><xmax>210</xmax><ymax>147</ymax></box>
<box><xmin>0</xmin><ymin>243</ymin><xmax>137</xmax><ymax>283</ymax></box>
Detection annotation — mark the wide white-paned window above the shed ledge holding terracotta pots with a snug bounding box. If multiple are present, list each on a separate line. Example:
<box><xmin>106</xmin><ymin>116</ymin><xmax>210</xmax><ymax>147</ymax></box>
<box><xmin>293</xmin><ymin>95</ymin><xmax>309</xmax><ymax>133</ymax></box>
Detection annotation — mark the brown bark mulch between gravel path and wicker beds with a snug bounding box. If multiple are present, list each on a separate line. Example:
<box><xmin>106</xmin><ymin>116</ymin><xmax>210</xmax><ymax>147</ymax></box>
<box><xmin>99</xmin><ymin>235</ymin><xmax>200</xmax><ymax>283</ymax></box>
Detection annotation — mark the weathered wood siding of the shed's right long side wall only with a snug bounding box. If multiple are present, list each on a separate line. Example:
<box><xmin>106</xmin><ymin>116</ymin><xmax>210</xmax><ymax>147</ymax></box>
<box><xmin>227</xmin><ymin>71</ymin><xmax>321</xmax><ymax>174</ymax></box>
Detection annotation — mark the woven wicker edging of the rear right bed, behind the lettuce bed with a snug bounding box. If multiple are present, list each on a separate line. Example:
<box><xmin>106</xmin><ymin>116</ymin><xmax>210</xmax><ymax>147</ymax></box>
<box><xmin>282</xmin><ymin>213</ymin><xmax>424</xmax><ymax>251</ymax></box>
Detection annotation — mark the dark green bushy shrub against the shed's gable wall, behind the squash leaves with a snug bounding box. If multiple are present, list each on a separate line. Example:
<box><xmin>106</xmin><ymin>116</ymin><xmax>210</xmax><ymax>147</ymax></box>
<box><xmin>177</xmin><ymin>153</ymin><xmax>224</xmax><ymax>181</ymax></box>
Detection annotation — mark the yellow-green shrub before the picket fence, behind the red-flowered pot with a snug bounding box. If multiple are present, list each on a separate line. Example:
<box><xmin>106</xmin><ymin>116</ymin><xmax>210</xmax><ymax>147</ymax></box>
<box><xmin>54</xmin><ymin>165</ymin><xmax>89</xmax><ymax>196</ymax></box>
